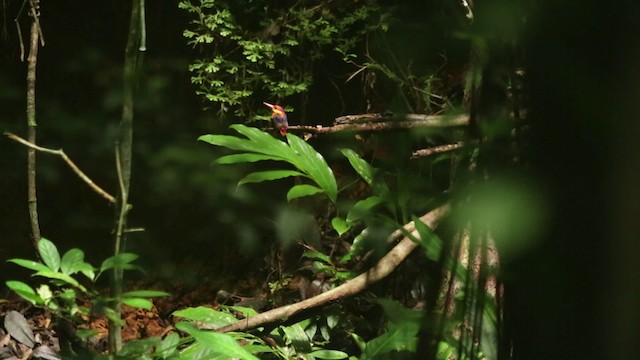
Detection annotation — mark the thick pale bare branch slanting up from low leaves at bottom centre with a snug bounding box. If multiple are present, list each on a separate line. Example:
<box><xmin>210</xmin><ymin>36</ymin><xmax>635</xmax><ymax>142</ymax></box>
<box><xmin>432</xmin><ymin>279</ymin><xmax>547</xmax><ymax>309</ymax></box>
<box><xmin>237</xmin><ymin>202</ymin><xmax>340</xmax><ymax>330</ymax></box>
<box><xmin>216</xmin><ymin>204</ymin><xmax>450</xmax><ymax>332</ymax></box>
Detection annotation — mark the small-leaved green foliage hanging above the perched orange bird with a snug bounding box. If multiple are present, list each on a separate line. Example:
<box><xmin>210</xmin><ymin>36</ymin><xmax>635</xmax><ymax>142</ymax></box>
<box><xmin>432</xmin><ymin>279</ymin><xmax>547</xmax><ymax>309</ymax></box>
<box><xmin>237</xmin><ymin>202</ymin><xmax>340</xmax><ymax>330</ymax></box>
<box><xmin>179</xmin><ymin>0</ymin><xmax>385</xmax><ymax>116</ymax></box>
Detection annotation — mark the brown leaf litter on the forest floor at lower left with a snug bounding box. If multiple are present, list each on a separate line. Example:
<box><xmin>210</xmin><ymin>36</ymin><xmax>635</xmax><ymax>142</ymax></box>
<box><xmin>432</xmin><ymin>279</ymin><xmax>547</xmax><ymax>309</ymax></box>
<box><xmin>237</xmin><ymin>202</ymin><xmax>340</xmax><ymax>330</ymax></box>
<box><xmin>0</xmin><ymin>258</ymin><xmax>276</xmax><ymax>359</ymax></box>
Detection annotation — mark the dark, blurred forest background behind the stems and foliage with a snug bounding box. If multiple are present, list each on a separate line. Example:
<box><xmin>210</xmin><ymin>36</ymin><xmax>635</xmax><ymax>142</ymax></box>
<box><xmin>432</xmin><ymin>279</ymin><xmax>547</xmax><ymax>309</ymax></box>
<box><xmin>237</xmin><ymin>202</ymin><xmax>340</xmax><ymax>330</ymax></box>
<box><xmin>0</xmin><ymin>0</ymin><xmax>640</xmax><ymax>359</ymax></box>
